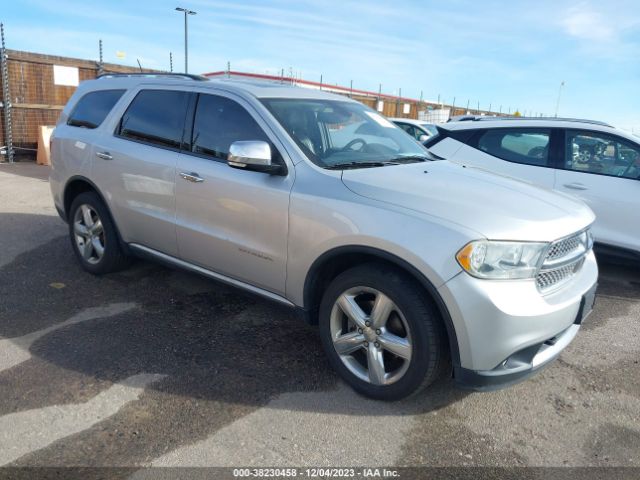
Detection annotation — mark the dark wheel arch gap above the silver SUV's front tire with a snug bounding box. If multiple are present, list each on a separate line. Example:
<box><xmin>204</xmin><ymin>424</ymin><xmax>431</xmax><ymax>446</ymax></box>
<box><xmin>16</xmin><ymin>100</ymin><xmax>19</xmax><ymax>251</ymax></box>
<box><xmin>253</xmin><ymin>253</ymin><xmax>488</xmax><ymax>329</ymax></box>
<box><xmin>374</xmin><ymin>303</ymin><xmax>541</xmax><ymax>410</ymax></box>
<box><xmin>302</xmin><ymin>245</ymin><xmax>460</xmax><ymax>365</ymax></box>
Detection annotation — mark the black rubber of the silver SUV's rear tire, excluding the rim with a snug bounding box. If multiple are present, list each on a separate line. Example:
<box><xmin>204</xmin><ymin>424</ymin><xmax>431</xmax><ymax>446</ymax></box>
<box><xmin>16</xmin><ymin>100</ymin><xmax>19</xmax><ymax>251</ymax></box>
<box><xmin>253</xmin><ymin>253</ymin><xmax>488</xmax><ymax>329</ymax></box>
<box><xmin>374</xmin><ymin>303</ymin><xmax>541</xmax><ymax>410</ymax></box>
<box><xmin>68</xmin><ymin>192</ymin><xmax>130</xmax><ymax>275</ymax></box>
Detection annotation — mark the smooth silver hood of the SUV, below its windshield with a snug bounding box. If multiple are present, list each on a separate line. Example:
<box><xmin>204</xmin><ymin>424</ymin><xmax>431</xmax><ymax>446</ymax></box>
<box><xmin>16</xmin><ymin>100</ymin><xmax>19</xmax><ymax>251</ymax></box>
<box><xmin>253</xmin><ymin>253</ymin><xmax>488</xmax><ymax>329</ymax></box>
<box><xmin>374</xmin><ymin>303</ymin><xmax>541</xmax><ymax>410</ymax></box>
<box><xmin>342</xmin><ymin>160</ymin><xmax>595</xmax><ymax>241</ymax></box>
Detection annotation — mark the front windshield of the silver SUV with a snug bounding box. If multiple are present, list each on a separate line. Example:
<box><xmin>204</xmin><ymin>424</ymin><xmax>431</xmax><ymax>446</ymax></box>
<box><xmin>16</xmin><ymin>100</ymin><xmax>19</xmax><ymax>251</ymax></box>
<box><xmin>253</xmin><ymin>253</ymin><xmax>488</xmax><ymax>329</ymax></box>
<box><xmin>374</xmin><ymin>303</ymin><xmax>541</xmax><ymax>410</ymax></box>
<box><xmin>262</xmin><ymin>98</ymin><xmax>434</xmax><ymax>168</ymax></box>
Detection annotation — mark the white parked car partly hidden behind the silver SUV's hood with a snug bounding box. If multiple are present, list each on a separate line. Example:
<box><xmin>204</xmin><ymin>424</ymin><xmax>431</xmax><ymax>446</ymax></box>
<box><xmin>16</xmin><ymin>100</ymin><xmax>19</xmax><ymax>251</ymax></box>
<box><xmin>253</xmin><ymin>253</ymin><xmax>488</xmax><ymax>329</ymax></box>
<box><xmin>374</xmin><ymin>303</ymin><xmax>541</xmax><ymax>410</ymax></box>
<box><xmin>427</xmin><ymin>117</ymin><xmax>640</xmax><ymax>259</ymax></box>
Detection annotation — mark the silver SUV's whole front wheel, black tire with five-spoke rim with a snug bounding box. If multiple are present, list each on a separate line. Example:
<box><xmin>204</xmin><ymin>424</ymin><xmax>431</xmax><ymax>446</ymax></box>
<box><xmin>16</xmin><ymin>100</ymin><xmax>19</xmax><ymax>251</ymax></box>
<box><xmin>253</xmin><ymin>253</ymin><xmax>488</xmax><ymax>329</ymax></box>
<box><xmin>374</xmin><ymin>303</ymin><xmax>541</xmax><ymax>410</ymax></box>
<box><xmin>319</xmin><ymin>263</ymin><xmax>449</xmax><ymax>400</ymax></box>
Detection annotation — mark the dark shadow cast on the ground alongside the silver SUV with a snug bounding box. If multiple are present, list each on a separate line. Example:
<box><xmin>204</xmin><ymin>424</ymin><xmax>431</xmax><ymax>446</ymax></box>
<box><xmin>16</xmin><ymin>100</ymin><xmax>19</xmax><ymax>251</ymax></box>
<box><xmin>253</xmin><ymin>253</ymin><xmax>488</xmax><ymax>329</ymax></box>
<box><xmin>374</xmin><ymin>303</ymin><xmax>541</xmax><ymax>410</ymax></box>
<box><xmin>0</xmin><ymin>216</ymin><xmax>468</xmax><ymax>415</ymax></box>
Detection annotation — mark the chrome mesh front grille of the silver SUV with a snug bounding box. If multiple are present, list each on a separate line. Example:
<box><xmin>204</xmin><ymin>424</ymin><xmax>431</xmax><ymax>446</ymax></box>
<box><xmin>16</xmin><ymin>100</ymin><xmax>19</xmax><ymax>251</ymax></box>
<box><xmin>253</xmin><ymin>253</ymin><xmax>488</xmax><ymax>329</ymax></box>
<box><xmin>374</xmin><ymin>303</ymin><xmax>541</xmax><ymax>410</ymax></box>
<box><xmin>536</xmin><ymin>230</ymin><xmax>593</xmax><ymax>293</ymax></box>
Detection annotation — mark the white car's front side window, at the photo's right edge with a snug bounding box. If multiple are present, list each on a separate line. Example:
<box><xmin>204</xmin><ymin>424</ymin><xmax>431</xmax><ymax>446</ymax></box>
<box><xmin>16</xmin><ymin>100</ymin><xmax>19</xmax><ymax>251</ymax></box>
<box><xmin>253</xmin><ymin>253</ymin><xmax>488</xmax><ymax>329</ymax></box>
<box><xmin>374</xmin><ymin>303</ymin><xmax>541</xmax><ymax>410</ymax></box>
<box><xmin>565</xmin><ymin>130</ymin><xmax>640</xmax><ymax>179</ymax></box>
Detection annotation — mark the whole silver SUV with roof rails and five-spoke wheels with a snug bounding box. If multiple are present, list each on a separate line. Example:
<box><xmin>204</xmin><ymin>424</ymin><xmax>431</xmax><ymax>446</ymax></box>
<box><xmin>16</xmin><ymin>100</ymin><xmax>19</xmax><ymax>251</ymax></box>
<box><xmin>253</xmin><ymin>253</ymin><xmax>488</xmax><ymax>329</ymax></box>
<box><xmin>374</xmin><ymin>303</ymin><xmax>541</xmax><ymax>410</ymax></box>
<box><xmin>51</xmin><ymin>75</ymin><xmax>598</xmax><ymax>400</ymax></box>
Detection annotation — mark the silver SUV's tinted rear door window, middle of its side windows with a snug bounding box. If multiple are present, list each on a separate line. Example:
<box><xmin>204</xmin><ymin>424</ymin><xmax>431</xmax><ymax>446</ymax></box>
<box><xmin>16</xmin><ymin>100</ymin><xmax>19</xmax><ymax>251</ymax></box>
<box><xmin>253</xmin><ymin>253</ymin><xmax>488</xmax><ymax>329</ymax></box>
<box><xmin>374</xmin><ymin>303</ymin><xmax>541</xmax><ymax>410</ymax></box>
<box><xmin>119</xmin><ymin>90</ymin><xmax>190</xmax><ymax>148</ymax></box>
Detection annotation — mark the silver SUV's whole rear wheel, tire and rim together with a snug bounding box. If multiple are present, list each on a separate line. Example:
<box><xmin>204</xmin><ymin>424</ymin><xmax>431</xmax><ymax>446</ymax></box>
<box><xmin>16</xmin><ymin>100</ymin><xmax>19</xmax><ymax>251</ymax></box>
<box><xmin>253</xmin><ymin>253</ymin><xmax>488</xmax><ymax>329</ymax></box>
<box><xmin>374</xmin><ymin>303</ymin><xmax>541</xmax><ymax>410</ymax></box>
<box><xmin>68</xmin><ymin>192</ymin><xmax>129</xmax><ymax>275</ymax></box>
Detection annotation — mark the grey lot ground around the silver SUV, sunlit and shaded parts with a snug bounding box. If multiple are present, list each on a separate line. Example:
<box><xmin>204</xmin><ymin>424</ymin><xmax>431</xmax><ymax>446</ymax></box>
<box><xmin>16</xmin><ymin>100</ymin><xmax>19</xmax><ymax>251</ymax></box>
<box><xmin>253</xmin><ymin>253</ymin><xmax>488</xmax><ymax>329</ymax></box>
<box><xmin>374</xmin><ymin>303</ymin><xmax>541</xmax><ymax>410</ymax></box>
<box><xmin>0</xmin><ymin>164</ymin><xmax>640</xmax><ymax>475</ymax></box>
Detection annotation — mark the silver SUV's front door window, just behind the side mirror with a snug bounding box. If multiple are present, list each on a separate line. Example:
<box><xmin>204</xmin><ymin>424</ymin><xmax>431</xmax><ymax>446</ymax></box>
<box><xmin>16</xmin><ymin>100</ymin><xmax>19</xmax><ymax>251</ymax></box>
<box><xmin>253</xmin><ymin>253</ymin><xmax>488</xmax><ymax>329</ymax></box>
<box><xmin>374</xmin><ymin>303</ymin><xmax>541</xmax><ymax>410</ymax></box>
<box><xmin>191</xmin><ymin>94</ymin><xmax>271</xmax><ymax>161</ymax></box>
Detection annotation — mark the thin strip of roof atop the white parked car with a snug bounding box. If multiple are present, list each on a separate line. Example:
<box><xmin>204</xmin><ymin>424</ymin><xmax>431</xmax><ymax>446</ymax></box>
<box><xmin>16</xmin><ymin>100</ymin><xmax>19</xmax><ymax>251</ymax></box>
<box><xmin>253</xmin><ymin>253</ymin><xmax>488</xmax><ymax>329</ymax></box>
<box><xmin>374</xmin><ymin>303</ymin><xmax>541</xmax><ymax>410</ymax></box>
<box><xmin>438</xmin><ymin>117</ymin><xmax>638</xmax><ymax>143</ymax></box>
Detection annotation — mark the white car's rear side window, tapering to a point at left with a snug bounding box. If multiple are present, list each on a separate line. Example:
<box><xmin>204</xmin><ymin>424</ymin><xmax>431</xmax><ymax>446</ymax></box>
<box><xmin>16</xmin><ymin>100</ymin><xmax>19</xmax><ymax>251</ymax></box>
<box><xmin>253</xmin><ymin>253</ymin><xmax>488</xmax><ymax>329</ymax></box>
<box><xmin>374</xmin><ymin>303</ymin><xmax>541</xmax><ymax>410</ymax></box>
<box><xmin>477</xmin><ymin>128</ymin><xmax>551</xmax><ymax>166</ymax></box>
